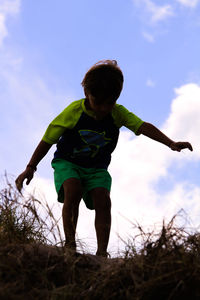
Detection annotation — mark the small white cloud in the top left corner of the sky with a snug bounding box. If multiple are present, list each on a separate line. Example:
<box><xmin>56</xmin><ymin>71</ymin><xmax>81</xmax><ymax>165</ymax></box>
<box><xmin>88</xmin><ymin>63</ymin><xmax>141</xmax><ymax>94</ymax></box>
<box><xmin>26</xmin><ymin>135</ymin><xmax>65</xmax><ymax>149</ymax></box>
<box><xmin>0</xmin><ymin>0</ymin><xmax>21</xmax><ymax>47</ymax></box>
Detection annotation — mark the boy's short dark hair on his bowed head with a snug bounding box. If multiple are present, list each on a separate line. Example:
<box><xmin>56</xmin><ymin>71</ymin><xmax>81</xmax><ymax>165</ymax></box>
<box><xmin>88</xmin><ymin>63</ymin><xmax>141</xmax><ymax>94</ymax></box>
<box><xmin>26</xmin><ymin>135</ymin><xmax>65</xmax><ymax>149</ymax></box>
<box><xmin>81</xmin><ymin>60</ymin><xmax>124</xmax><ymax>101</ymax></box>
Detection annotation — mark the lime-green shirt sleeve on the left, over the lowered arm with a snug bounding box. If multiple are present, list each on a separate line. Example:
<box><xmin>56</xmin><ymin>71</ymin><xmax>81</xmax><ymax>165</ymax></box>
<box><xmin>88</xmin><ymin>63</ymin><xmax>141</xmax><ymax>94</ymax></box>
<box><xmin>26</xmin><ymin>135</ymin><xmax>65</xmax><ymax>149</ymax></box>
<box><xmin>42</xmin><ymin>100</ymin><xmax>82</xmax><ymax>145</ymax></box>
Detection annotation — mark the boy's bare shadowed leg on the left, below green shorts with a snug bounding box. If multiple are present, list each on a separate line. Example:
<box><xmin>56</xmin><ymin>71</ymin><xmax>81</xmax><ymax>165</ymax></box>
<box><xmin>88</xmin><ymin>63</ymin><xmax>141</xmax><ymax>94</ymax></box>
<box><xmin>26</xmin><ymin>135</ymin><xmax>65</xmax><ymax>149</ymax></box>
<box><xmin>62</xmin><ymin>178</ymin><xmax>82</xmax><ymax>250</ymax></box>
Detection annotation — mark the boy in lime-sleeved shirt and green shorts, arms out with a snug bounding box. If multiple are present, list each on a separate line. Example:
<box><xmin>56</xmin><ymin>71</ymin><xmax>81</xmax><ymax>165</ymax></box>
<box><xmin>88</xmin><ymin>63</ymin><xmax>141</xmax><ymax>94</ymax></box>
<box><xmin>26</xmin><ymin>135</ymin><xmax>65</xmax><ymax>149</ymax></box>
<box><xmin>16</xmin><ymin>60</ymin><xmax>193</xmax><ymax>257</ymax></box>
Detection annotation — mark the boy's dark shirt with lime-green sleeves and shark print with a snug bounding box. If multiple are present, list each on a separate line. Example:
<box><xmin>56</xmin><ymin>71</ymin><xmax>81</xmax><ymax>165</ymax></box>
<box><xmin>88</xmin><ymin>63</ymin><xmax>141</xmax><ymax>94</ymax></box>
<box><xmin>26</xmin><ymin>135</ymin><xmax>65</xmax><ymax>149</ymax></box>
<box><xmin>42</xmin><ymin>99</ymin><xmax>143</xmax><ymax>169</ymax></box>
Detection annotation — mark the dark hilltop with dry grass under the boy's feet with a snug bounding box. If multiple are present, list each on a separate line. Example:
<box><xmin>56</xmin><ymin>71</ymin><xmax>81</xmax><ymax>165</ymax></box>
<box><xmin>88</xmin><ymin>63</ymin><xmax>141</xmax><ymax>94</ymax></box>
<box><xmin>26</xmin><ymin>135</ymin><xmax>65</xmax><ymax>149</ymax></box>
<box><xmin>0</xmin><ymin>179</ymin><xmax>200</xmax><ymax>300</ymax></box>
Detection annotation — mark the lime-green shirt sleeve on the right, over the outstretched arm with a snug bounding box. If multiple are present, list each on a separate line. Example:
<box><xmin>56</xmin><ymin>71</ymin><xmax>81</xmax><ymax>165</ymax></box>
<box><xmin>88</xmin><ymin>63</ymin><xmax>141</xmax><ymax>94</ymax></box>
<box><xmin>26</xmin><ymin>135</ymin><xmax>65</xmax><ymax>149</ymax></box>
<box><xmin>113</xmin><ymin>104</ymin><xmax>144</xmax><ymax>135</ymax></box>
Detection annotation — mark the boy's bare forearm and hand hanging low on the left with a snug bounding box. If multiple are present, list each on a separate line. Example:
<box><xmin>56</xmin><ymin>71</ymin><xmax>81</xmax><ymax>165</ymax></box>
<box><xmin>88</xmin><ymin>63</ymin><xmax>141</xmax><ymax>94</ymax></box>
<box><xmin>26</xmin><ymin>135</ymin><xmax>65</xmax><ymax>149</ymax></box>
<box><xmin>15</xmin><ymin>140</ymin><xmax>52</xmax><ymax>191</ymax></box>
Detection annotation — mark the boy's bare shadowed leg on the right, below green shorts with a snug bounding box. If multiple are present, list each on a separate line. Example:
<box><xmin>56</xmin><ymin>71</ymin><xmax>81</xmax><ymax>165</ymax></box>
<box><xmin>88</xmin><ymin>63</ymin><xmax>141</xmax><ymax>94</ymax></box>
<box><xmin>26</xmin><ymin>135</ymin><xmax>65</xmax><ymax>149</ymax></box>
<box><xmin>90</xmin><ymin>187</ymin><xmax>111</xmax><ymax>256</ymax></box>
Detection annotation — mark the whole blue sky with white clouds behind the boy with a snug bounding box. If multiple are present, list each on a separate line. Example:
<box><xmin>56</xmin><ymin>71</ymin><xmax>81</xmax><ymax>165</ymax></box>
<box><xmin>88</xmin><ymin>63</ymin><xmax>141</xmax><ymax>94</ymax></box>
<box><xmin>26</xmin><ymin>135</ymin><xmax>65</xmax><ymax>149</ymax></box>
<box><xmin>0</xmin><ymin>0</ymin><xmax>200</xmax><ymax>251</ymax></box>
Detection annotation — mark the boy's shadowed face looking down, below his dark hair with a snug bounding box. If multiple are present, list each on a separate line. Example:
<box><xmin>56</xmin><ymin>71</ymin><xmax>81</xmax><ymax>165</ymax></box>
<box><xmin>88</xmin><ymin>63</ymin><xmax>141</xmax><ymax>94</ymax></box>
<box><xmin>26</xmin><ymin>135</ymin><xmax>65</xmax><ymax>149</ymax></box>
<box><xmin>86</xmin><ymin>93</ymin><xmax>116</xmax><ymax>120</ymax></box>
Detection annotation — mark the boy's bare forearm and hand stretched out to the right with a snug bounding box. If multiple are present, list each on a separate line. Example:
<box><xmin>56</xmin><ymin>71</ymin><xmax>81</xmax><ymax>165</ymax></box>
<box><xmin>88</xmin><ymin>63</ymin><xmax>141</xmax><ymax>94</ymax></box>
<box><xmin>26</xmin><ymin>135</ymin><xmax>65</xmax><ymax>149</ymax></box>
<box><xmin>137</xmin><ymin>122</ymin><xmax>193</xmax><ymax>152</ymax></box>
